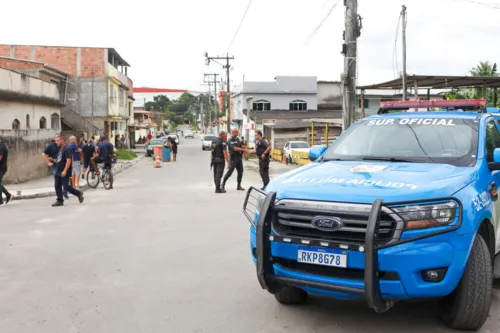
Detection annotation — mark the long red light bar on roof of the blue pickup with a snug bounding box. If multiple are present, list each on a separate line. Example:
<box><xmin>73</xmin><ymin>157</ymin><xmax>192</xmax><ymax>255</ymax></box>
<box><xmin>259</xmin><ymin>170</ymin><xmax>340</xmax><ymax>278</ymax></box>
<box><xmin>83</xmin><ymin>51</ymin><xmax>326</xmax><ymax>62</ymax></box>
<box><xmin>380</xmin><ymin>99</ymin><xmax>486</xmax><ymax>110</ymax></box>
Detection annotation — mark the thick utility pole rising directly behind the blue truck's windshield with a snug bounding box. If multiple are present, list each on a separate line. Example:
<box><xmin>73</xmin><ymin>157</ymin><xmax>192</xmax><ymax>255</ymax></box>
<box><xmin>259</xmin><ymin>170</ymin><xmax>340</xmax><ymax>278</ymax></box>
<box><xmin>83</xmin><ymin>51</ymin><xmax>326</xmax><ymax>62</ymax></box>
<box><xmin>342</xmin><ymin>0</ymin><xmax>362</xmax><ymax>131</ymax></box>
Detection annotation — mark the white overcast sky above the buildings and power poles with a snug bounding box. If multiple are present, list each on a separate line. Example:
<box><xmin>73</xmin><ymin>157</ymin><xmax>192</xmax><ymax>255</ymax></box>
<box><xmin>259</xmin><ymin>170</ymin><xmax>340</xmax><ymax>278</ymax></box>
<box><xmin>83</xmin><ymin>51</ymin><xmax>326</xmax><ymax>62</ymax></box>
<box><xmin>0</xmin><ymin>0</ymin><xmax>500</xmax><ymax>90</ymax></box>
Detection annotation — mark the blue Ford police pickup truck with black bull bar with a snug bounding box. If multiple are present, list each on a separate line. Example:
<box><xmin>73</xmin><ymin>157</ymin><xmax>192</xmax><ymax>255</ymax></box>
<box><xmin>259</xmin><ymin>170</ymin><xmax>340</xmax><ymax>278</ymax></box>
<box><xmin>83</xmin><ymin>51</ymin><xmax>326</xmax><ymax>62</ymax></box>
<box><xmin>243</xmin><ymin>100</ymin><xmax>500</xmax><ymax>330</ymax></box>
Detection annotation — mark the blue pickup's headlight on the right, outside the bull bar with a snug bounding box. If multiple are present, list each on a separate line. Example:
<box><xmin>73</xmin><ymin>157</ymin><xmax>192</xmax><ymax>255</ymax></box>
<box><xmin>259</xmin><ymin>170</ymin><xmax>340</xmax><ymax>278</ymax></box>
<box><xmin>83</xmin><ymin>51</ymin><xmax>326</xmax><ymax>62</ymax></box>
<box><xmin>391</xmin><ymin>202</ymin><xmax>457</xmax><ymax>230</ymax></box>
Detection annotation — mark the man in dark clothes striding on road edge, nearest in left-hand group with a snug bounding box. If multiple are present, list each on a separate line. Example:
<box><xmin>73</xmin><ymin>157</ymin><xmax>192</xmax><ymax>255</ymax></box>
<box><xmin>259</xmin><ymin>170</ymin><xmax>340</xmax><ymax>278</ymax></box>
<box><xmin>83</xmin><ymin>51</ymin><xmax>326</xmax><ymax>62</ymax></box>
<box><xmin>52</xmin><ymin>136</ymin><xmax>83</xmax><ymax>207</ymax></box>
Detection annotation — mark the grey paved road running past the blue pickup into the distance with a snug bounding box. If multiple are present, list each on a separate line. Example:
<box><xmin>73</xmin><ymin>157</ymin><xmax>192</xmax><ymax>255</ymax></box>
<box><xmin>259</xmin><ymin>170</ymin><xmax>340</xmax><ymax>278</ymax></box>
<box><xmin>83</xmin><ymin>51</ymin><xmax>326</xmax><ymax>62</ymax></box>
<box><xmin>0</xmin><ymin>139</ymin><xmax>500</xmax><ymax>333</ymax></box>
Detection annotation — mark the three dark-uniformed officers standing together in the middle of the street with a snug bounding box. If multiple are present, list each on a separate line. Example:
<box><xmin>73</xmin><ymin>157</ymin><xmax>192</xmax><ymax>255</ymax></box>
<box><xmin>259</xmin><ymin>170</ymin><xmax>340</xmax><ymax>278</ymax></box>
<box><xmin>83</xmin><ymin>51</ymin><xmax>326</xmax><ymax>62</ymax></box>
<box><xmin>211</xmin><ymin>129</ymin><xmax>272</xmax><ymax>193</ymax></box>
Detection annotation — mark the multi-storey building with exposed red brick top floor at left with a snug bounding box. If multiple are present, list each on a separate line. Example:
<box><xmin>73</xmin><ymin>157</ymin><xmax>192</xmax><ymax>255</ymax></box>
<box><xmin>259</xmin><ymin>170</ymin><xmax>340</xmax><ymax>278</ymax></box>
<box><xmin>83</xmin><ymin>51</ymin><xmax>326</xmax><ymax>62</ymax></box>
<box><xmin>0</xmin><ymin>45</ymin><xmax>132</xmax><ymax>136</ymax></box>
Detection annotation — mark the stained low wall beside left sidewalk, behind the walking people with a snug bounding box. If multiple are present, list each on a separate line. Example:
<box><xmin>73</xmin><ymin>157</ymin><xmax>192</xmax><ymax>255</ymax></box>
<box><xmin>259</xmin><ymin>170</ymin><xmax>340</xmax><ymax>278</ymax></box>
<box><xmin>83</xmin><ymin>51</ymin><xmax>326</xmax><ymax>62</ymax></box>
<box><xmin>0</xmin><ymin>129</ymin><xmax>56</xmax><ymax>184</ymax></box>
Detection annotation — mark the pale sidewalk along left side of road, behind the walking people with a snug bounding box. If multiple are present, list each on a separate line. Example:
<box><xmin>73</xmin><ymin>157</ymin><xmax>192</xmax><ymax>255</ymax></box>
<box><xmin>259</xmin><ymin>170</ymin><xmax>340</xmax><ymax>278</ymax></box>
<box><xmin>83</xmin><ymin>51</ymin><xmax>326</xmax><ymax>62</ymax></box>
<box><xmin>6</xmin><ymin>154</ymin><xmax>144</xmax><ymax>200</ymax></box>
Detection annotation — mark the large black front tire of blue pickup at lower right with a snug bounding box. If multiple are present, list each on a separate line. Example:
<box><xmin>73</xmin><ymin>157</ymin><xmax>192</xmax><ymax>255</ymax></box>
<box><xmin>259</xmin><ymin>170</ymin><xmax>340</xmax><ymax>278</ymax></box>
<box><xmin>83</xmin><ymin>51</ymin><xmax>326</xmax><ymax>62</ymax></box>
<box><xmin>440</xmin><ymin>234</ymin><xmax>493</xmax><ymax>330</ymax></box>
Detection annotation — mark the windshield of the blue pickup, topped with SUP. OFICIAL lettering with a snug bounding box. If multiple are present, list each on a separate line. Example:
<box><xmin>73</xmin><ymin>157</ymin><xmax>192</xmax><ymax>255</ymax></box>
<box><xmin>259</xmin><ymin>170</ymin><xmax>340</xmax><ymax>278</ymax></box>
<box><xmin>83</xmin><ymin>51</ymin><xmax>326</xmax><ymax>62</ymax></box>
<box><xmin>323</xmin><ymin>118</ymin><xmax>478</xmax><ymax>166</ymax></box>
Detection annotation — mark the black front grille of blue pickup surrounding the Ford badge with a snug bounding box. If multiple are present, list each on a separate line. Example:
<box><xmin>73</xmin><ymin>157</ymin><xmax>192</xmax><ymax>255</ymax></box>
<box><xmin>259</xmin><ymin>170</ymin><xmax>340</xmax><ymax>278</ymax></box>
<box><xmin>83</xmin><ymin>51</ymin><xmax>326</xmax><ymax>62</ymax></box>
<box><xmin>273</xmin><ymin>200</ymin><xmax>404</xmax><ymax>244</ymax></box>
